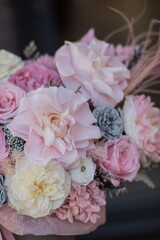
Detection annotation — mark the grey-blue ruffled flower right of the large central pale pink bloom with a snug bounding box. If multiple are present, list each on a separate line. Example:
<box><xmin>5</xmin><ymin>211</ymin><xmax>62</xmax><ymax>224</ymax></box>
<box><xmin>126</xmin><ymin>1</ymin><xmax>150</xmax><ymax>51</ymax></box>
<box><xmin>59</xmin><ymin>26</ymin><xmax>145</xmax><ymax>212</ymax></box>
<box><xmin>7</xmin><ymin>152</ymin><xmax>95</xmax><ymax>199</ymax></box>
<box><xmin>93</xmin><ymin>106</ymin><xmax>123</xmax><ymax>140</ymax></box>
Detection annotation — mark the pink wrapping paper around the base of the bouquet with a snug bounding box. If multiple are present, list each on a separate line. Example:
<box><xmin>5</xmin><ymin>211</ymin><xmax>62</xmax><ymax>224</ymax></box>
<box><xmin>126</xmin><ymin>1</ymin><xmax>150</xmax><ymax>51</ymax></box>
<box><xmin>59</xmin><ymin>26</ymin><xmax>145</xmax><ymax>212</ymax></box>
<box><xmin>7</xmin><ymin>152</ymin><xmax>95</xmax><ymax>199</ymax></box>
<box><xmin>0</xmin><ymin>205</ymin><xmax>106</xmax><ymax>236</ymax></box>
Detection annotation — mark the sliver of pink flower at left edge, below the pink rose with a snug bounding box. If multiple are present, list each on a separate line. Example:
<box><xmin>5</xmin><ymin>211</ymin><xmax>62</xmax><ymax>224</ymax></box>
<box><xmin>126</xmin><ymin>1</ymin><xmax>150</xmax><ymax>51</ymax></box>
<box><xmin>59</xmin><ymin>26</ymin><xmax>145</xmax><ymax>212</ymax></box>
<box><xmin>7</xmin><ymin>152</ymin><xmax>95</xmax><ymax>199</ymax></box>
<box><xmin>0</xmin><ymin>128</ymin><xmax>9</xmax><ymax>165</ymax></box>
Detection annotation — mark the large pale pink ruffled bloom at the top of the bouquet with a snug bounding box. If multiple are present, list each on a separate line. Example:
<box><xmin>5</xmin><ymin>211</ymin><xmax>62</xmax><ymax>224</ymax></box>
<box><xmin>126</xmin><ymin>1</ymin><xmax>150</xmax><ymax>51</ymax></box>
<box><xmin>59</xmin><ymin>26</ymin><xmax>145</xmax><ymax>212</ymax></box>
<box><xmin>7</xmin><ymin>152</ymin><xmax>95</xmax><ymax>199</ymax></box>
<box><xmin>55</xmin><ymin>35</ymin><xmax>130</xmax><ymax>107</ymax></box>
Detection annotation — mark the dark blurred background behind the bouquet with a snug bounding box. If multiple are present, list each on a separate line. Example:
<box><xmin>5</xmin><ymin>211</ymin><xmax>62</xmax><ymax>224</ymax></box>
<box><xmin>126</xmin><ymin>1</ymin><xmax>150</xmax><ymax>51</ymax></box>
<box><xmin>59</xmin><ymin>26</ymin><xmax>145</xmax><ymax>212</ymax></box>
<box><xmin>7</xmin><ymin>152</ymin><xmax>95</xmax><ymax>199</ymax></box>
<box><xmin>0</xmin><ymin>0</ymin><xmax>160</xmax><ymax>240</ymax></box>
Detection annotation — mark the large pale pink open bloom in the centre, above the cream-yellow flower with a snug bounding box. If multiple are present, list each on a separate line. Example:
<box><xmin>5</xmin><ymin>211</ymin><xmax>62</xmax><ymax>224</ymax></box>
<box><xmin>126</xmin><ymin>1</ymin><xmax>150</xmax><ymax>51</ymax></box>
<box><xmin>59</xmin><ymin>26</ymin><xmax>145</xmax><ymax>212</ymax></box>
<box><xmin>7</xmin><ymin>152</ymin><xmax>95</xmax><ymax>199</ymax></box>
<box><xmin>9</xmin><ymin>87</ymin><xmax>100</xmax><ymax>167</ymax></box>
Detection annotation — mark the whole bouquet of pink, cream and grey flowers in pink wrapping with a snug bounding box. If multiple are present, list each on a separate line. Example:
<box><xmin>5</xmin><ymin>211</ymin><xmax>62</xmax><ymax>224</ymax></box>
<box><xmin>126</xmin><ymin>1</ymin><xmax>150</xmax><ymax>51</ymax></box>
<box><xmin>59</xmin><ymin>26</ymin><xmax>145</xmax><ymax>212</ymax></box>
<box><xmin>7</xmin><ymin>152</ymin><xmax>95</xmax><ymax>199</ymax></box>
<box><xmin>0</xmin><ymin>15</ymin><xmax>160</xmax><ymax>238</ymax></box>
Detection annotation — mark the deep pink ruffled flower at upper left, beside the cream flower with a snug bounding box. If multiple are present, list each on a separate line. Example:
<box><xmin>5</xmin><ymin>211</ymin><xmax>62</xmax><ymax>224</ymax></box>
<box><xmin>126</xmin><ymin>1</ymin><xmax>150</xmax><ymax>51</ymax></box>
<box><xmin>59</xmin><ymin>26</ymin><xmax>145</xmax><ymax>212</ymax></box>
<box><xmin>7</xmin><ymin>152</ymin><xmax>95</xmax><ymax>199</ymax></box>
<box><xmin>9</xmin><ymin>62</ymin><xmax>59</xmax><ymax>92</ymax></box>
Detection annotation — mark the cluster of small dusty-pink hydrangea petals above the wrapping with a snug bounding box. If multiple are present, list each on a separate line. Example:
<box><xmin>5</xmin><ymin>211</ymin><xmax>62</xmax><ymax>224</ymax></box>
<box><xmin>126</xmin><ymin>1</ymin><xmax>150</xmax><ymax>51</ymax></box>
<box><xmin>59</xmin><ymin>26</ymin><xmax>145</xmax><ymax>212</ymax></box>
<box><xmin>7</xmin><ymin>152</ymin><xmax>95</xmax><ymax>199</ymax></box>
<box><xmin>56</xmin><ymin>180</ymin><xmax>106</xmax><ymax>224</ymax></box>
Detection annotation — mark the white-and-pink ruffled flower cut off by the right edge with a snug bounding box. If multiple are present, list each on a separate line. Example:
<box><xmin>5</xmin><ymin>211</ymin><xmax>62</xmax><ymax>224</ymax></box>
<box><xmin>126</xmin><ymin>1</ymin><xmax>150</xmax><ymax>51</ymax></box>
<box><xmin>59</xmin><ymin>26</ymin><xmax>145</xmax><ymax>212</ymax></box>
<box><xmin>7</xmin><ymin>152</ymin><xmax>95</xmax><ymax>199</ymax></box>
<box><xmin>122</xmin><ymin>95</ymin><xmax>160</xmax><ymax>166</ymax></box>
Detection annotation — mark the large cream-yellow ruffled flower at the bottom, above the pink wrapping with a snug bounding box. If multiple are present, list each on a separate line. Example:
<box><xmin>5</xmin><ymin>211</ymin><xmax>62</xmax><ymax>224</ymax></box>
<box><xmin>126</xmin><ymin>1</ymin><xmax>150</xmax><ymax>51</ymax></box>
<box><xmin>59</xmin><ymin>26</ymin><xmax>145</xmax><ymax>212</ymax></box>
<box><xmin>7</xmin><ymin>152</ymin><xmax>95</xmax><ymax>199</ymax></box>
<box><xmin>5</xmin><ymin>157</ymin><xmax>71</xmax><ymax>218</ymax></box>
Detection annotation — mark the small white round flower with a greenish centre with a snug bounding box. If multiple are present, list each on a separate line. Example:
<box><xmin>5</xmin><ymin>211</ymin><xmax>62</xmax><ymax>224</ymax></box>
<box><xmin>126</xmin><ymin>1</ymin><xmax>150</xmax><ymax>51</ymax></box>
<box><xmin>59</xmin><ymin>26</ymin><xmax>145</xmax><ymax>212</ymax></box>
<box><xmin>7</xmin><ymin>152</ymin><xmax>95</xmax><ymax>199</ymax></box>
<box><xmin>69</xmin><ymin>158</ymin><xmax>96</xmax><ymax>185</ymax></box>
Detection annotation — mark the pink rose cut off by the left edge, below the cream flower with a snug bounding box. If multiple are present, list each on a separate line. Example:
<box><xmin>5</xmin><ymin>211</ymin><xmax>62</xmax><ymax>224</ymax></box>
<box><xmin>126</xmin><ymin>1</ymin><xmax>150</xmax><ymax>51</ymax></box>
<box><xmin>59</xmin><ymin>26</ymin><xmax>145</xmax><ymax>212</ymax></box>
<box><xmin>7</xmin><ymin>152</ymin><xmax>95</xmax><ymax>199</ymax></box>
<box><xmin>0</xmin><ymin>82</ymin><xmax>25</xmax><ymax>124</ymax></box>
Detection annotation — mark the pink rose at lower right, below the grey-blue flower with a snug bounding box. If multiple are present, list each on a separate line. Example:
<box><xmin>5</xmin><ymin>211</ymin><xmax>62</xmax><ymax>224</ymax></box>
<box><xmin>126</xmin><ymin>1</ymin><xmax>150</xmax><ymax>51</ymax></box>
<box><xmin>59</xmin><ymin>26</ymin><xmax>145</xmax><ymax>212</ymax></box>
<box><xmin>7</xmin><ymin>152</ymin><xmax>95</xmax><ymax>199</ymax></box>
<box><xmin>99</xmin><ymin>136</ymin><xmax>140</xmax><ymax>183</ymax></box>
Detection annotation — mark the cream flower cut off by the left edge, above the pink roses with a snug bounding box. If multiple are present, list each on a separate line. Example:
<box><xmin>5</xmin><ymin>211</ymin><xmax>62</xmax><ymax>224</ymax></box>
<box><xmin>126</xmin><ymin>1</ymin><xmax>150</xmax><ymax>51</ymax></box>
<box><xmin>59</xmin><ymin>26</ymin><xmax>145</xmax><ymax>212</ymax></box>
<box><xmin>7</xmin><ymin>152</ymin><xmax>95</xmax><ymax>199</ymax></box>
<box><xmin>0</xmin><ymin>49</ymin><xmax>24</xmax><ymax>81</ymax></box>
